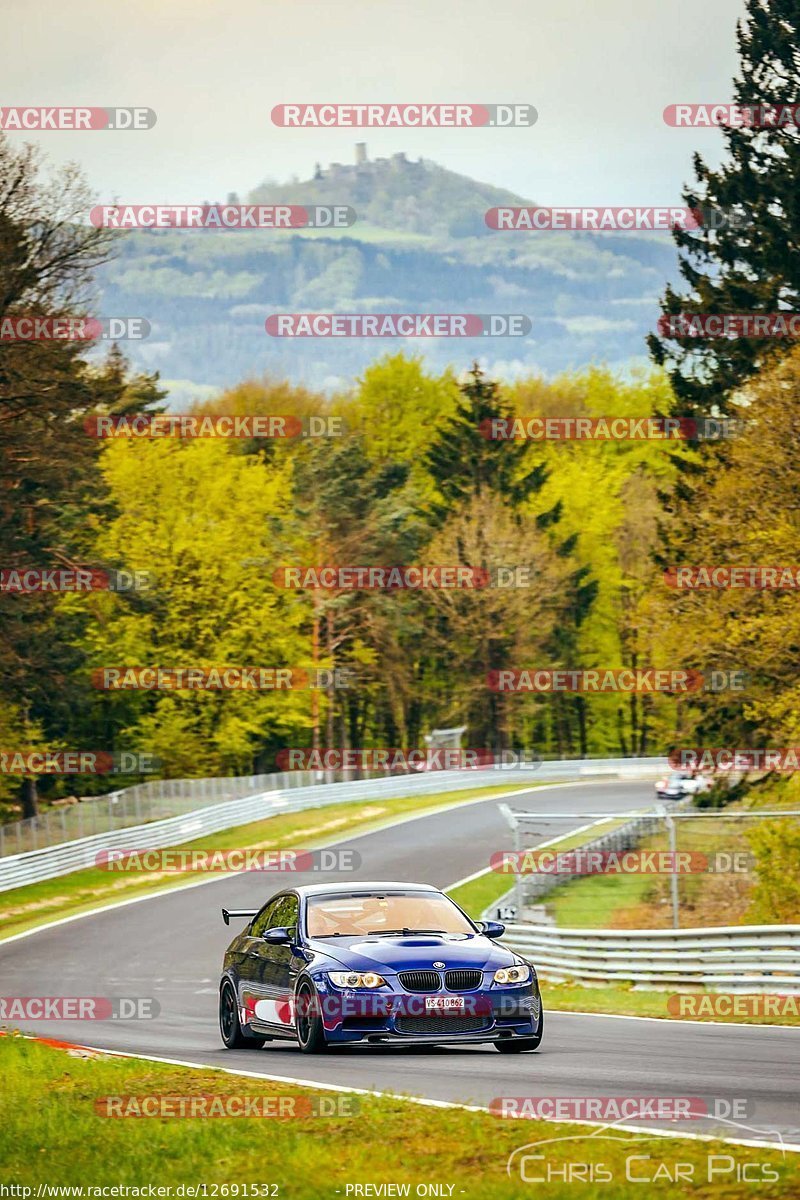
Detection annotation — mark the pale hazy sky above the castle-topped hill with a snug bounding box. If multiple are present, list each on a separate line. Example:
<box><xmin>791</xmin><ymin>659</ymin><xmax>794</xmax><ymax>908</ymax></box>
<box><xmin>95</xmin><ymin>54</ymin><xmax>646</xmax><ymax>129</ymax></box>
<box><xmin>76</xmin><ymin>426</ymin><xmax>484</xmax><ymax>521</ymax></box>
<box><xmin>0</xmin><ymin>0</ymin><xmax>744</xmax><ymax>204</ymax></box>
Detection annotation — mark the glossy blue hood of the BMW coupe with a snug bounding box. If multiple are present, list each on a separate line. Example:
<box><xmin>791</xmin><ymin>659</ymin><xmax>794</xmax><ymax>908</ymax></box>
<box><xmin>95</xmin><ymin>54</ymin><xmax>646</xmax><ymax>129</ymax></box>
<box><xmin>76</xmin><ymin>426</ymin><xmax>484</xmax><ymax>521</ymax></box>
<box><xmin>303</xmin><ymin>934</ymin><xmax>515</xmax><ymax>973</ymax></box>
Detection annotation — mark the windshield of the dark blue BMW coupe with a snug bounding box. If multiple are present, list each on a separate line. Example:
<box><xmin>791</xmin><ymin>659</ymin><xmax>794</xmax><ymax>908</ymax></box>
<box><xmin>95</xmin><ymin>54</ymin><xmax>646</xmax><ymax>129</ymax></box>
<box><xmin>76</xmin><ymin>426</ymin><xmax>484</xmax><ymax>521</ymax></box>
<box><xmin>306</xmin><ymin>892</ymin><xmax>475</xmax><ymax>937</ymax></box>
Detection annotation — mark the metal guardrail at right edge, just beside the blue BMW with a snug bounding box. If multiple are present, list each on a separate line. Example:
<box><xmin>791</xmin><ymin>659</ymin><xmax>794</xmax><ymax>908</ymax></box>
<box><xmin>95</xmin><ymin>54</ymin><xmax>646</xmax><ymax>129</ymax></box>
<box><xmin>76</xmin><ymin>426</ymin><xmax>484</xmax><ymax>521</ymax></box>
<box><xmin>504</xmin><ymin>924</ymin><xmax>800</xmax><ymax>995</ymax></box>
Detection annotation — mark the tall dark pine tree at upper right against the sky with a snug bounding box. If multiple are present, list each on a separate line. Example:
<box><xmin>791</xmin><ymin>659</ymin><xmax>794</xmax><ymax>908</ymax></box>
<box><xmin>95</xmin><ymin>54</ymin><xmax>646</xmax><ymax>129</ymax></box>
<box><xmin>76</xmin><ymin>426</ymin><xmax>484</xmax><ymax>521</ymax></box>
<box><xmin>648</xmin><ymin>0</ymin><xmax>800</xmax><ymax>416</ymax></box>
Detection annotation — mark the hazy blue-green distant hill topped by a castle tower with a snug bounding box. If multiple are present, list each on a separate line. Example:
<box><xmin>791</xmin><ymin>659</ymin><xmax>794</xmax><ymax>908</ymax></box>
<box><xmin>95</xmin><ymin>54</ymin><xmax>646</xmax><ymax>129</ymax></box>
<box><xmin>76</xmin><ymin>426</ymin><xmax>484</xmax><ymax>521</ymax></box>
<box><xmin>95</xmin><ymin>150</ymin><xmax>675</xmax><ymax>404</ymax></box>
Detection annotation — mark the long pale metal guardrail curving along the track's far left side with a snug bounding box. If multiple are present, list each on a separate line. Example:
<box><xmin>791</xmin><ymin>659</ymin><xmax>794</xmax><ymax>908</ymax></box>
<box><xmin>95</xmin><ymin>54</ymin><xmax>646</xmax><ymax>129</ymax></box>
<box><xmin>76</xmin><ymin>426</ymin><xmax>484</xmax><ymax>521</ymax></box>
<box><xmin>0</xmin><ymin>758</ymin><xmax>666</xmax><ymax>892</ymax></box>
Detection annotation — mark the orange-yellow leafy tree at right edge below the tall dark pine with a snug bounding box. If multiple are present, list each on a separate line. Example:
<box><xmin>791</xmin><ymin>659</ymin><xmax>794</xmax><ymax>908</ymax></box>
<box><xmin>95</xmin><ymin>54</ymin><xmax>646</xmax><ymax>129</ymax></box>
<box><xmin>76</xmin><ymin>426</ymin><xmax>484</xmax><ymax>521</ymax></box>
<box><xmin>650</xmin><ymin>349</ymin><xmax>800</xmax><ymax>746</ymax></box>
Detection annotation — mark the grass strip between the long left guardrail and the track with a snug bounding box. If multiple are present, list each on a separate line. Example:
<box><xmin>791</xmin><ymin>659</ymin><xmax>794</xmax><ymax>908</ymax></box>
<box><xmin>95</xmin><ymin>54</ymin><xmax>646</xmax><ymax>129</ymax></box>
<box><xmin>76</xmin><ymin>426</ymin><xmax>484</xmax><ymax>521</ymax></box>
<box><xmin>0</xmin><ymin>784</ymin><xmax>542</xmax><ymax>941</ymax></box>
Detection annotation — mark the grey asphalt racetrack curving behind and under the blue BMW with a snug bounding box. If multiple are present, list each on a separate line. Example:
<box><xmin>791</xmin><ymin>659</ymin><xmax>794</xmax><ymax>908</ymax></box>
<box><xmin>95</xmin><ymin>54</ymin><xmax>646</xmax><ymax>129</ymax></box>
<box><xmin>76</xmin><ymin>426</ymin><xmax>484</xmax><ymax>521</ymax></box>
<box><xmin>0</xmin><ymin>780</ymin><xmax>800</xmax><ymax>1145</ymax></box>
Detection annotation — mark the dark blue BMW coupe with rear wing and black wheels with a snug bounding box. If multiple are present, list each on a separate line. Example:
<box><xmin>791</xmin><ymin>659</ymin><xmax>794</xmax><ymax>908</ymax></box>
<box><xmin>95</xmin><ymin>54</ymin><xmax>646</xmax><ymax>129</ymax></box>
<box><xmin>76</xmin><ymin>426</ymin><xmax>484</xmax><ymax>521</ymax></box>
<box><xmin>219</xmin><ymin>883</ymin><xmax>543</xmax><ymax>1054</ymax></box>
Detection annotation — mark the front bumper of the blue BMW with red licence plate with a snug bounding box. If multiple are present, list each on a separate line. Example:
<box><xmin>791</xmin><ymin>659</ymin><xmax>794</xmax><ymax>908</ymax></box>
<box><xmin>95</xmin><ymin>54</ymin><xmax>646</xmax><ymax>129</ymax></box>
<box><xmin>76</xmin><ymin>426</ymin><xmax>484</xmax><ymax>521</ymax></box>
<box><xmin>309</xmin><ymin>978</ymin><xmax>541</xmax><ymax>1044</ymax></box>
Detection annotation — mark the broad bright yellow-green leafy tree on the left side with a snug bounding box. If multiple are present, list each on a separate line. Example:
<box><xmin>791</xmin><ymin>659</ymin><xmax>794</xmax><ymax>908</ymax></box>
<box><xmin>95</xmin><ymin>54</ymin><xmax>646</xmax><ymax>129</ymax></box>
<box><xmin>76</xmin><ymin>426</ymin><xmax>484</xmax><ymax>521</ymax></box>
<box><xmin>76</xmin><ymin>438</ymin><xmax>311</xmax><ymax>778</ymax></box>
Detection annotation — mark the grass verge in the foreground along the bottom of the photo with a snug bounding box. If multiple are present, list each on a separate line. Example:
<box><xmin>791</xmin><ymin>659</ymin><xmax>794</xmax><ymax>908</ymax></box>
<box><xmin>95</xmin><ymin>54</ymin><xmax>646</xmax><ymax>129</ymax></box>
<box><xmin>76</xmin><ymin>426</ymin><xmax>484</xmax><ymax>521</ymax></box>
<box><xmin>0</xmin><ymin>1037</ymin><xmax>796</xmax><ymax>1200</ymax></box>
